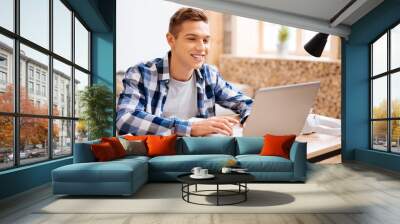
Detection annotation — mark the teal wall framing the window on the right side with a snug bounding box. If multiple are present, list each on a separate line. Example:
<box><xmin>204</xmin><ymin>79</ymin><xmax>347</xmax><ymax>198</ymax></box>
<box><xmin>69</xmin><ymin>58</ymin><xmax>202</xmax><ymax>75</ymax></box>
<box><xmin>342</xmin><ymin>0</ymin><xmax>400</xmax><ymax>170</ymax></box>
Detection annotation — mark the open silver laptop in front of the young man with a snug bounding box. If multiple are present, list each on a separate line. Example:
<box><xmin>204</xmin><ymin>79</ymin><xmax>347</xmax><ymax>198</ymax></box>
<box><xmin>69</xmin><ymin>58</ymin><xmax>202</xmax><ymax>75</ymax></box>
<box><xmin>243</xmin><ymin>82</ymin><xmax>320</xmax><ymax>136</ymax></box>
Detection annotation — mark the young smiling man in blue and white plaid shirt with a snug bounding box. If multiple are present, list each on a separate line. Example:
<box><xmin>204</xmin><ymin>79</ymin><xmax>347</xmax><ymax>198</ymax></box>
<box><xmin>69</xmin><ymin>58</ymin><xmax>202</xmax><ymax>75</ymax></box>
<box><xmin>117</xmin><ymin>8</ymin><xmax>253</xmax><ymax>136</ymax></box>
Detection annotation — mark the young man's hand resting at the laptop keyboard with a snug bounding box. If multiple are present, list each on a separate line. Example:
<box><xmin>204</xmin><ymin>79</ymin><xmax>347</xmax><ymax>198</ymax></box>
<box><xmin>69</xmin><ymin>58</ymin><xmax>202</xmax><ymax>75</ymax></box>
<box><xmin>190</xmin><ymin>116</ymin><xmax>240</xmax><ymax>136</ymax></box>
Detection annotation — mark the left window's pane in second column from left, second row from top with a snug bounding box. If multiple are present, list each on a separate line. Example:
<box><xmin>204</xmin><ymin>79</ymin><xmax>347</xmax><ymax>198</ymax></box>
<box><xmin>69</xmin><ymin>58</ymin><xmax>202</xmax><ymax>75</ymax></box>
<box><xmin>20</xmin><ymin>44</ymin><xmax>49</xmax><ymax>114</ymax></box>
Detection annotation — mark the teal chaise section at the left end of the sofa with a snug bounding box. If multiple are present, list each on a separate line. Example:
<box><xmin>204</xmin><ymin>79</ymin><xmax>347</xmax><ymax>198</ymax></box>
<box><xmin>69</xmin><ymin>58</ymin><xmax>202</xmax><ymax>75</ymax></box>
<box><xmin>52</xmin><ymin>157</ymin><xmax>148</xmax><ymax>195</ymax></box>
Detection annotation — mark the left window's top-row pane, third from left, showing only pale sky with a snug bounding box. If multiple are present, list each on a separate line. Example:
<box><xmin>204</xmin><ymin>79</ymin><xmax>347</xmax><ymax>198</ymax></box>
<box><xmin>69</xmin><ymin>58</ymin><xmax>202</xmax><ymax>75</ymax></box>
<box><xmin>53</xmin><ymin>0</ymin><xmax>72</xmax><ymax>60</ymax></box>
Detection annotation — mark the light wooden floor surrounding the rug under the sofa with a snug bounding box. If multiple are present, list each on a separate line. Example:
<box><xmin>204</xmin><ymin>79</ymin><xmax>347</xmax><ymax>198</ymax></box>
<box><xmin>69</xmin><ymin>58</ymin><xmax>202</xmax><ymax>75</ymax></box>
<box><xmin>0</xmin><ymin>163</ymin><xmax>400</xmax><ymax>224</ymax></box>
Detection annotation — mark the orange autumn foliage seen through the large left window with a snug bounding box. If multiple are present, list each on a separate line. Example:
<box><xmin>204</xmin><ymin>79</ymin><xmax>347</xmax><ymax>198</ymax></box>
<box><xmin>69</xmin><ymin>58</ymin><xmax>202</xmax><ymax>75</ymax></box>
<box><xmin>0</xmin><ymin>85</ymin><xmax>59</xmax><ymax>149</ymax></box>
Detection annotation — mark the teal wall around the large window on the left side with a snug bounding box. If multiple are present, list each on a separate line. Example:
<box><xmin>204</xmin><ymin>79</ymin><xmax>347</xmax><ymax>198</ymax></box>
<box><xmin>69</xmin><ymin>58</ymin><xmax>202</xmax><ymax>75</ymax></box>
<box><xmin>0</xmin><ymin>0</ymin><xmax>116</xmax><ymax>199</ymax></box>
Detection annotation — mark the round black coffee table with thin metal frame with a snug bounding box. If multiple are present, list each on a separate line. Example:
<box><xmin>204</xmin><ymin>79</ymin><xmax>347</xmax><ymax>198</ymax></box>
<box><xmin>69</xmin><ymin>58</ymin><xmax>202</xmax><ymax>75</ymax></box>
<box><xmin>177</xmin><ymin>173</ymin><xmax>255</xmax><ymax>206</ymax></box>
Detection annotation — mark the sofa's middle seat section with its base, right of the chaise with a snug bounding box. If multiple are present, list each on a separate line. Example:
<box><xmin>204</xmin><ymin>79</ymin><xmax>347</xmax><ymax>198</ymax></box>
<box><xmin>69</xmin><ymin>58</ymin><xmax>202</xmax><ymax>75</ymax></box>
<box><xmin>149</xmin><ymin>154</ymin><xmax>235</xmax><ymax>181</ymax></box>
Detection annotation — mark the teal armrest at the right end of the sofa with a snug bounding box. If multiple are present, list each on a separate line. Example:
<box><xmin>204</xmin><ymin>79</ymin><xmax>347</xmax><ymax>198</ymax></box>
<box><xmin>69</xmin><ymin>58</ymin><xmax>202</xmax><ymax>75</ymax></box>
<box><xmin>290</xmin><ymin>142</ymin><xmax>307</xmax><ymax>181</ymax></box>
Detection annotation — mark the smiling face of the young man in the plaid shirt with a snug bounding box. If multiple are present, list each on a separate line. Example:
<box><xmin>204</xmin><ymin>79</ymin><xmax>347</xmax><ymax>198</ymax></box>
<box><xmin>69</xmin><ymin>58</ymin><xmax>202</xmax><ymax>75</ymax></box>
<box><xmin>167</xmin><ymin>21</ymin><xmax>210</xmax><ymax>69</ymax></box>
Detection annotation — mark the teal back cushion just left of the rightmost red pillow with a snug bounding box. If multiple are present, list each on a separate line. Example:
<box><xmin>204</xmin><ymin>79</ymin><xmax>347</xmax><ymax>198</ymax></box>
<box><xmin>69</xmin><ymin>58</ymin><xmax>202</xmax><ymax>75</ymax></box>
<box><xmin>236</xmin><ymin>137</ymin><xmax>264</xmax><ymax>155</ymax></box>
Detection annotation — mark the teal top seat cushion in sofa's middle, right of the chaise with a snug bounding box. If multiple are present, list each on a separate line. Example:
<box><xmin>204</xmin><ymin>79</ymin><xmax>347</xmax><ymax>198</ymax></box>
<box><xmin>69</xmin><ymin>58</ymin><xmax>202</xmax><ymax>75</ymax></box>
<box><xmin>149</xmin><ymin>154</ymin><xmax>235</xmax><ymax>172</ymax></box>
